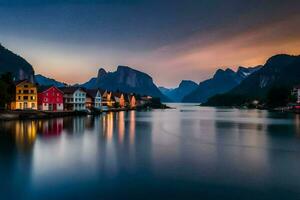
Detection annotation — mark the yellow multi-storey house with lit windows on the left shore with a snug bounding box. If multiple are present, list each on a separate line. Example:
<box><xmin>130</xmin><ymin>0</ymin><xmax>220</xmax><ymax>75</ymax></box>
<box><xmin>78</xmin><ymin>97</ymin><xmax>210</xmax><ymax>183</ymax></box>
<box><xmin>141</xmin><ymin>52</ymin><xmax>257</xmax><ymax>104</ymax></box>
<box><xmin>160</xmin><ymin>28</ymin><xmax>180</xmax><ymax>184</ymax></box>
<box><xmin>11</xmin><ymin>80</ymin><xmax>38</xmax><ymax>110</ymax></box>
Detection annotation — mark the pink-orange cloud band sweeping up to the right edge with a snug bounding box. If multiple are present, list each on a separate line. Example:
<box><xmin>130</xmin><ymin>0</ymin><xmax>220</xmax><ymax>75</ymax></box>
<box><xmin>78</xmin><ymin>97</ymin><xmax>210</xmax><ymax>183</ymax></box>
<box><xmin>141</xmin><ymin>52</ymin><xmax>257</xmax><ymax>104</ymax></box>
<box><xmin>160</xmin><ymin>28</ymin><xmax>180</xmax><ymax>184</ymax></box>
<box><xmin>132</xmin><ymin>15</ymin><xmax>300</xmax><ymax>85</ymax></box>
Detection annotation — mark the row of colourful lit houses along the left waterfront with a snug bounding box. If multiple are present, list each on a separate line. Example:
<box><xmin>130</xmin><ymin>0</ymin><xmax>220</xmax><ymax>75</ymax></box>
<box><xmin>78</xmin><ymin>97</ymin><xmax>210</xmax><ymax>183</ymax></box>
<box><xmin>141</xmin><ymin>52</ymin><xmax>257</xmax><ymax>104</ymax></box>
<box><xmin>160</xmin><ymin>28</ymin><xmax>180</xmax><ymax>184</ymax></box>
<box><xmin>0</xmin><ymin>80</ymin><xmax>162</xmax><ymax>119</ymax></box>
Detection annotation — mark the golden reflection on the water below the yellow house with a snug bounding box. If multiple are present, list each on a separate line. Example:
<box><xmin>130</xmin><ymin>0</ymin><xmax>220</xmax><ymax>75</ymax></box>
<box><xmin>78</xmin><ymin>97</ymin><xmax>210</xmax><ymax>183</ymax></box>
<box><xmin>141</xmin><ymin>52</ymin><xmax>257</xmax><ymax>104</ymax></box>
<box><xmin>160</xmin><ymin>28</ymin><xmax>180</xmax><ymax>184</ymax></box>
<box><xmin>15</xmin><ymin>121</ymin><xmax>37</xmax><ymax>149</ymax></box>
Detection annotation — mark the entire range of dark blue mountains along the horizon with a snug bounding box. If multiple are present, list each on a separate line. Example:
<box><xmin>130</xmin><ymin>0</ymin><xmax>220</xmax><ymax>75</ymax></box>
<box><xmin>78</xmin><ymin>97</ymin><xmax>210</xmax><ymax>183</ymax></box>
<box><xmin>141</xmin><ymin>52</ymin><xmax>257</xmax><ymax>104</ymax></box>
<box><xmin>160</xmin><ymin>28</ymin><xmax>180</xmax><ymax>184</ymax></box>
<box><xmin>0</xmin><ymin>44</ymin><xmax>300</xmax><ymax>105</ymax></box>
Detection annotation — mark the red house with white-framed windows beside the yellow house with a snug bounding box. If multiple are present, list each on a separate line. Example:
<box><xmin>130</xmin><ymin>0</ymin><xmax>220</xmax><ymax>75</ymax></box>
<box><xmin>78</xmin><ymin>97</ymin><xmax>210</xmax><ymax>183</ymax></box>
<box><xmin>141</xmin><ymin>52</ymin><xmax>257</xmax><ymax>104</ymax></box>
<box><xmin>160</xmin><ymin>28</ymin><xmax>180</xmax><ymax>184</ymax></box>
<box><xmin>38</xmin><ymin>86</ymin><xmax>64</xmax><ymax>111</ymax></box>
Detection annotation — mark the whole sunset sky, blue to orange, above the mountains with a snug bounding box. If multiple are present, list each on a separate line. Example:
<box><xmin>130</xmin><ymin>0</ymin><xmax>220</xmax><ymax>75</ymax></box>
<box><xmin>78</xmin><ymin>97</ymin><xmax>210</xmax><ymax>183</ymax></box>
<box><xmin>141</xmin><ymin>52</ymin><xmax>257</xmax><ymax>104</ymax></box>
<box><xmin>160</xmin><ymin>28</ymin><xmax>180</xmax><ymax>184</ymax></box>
<box><xmin>0</xmin><ymin>0</ymin><xmax>300</xmax><ymax>87</ymax></box>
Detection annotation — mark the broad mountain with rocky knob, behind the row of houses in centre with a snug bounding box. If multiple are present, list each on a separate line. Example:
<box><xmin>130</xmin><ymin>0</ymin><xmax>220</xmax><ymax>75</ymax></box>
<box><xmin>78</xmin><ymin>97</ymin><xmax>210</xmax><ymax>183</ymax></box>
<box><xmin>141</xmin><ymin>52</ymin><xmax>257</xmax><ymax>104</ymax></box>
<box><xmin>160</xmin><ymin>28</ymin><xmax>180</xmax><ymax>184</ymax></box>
<box><xmin>81</xmin><ymin>66</ymin><xmax>168</xmax><ymax>101</ymax></box>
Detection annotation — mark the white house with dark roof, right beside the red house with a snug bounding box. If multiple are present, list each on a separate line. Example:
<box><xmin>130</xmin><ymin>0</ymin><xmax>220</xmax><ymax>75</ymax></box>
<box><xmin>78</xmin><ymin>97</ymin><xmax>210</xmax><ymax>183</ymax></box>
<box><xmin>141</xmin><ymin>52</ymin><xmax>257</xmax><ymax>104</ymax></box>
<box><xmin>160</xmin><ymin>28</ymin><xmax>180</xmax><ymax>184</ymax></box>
<box><xmin>59</xmin><ymin>87</ymin><xmax>86</xmax><ymax>111</ymax></box>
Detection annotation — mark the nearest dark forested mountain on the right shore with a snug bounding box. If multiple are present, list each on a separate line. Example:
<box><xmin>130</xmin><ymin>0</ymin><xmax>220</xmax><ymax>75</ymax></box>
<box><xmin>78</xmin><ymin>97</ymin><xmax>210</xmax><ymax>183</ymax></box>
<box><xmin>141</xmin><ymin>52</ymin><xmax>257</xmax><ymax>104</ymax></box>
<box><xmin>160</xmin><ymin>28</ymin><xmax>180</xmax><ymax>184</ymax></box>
<box><xmin>207</xmin><ymin>54</ymin><xmax>300</xmax><ymax>105</ymax></box>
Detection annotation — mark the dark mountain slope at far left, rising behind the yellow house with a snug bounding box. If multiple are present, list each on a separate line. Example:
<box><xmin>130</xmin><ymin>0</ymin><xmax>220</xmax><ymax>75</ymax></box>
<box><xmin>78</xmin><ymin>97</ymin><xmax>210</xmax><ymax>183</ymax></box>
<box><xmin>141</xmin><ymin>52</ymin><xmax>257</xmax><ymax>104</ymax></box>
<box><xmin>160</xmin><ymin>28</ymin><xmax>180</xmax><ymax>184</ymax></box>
<box><xmin>0</xmin><ymin>44</ymin><xmax>34</xmax><ymax>81</ymax></box>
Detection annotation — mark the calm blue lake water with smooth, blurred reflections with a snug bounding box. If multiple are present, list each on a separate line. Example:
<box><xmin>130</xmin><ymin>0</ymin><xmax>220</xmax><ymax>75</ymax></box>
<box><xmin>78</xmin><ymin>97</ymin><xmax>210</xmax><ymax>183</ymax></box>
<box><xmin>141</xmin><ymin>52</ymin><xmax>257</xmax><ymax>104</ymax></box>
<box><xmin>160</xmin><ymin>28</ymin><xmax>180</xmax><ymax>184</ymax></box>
<box><xmin>0</xmin><ymin>105</ymin><xmax>300</xmax><ymax>199</ymax></box>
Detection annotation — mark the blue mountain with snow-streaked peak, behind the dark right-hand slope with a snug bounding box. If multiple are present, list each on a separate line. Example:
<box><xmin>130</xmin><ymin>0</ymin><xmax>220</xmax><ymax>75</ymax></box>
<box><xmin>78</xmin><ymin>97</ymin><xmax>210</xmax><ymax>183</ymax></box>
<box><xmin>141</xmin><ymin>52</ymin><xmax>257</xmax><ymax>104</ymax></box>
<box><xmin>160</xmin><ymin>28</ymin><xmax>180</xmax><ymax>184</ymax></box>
<box><xmin>183</xmin><ymin>66</ymin><xmax>261</xmax><ymax>103</ymax></box>
